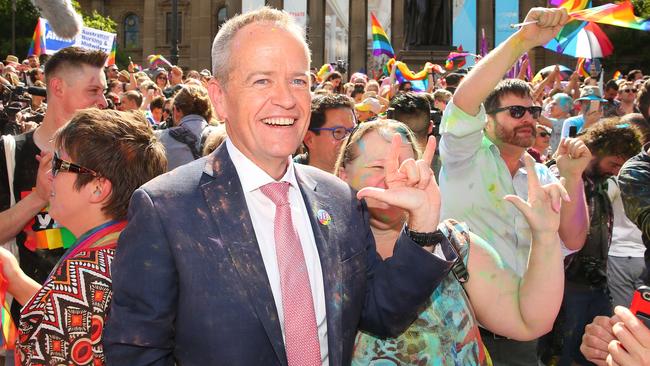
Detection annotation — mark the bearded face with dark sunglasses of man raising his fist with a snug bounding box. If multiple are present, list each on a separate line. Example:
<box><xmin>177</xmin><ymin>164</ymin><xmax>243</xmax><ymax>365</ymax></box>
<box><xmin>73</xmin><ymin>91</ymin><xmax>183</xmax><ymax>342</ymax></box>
<box><xmin>487</xmin><ymin>94</ymin><xmax>537</xmax><ymax>148</ymax></box>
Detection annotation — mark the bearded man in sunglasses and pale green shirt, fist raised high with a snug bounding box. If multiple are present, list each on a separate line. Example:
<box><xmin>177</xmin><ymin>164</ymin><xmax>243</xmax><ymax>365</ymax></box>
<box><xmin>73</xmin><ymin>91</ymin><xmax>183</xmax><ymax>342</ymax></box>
<box><xmin>440</xmin><ymin>8</ymin><xmax>591</xmax><ymax>365</ymax></box>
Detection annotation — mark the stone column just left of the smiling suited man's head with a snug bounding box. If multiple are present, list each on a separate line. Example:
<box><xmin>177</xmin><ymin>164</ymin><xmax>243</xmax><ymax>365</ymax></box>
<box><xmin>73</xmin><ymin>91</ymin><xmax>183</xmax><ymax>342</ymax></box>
<box><xmin>189</xmin><ymin>1</ymin><xmax>211</xmax><ymax>70</ymax></box>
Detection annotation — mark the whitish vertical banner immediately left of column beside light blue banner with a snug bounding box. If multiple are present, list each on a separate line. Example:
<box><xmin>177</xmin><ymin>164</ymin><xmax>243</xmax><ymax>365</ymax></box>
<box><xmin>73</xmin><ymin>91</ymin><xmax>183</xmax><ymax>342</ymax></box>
<box><xmin>325</xmin><ymin>0</ymin><xmax>350</xmax><ymax>70</ymax></box>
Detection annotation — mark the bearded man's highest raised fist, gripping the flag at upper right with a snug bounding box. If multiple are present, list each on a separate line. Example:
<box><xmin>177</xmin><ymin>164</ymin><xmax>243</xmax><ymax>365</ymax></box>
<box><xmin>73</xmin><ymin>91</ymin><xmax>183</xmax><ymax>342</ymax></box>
<box><xmin>517</xmin><ymin>8</ymin><xmax>569</xmax><ymax>49</ymax></box>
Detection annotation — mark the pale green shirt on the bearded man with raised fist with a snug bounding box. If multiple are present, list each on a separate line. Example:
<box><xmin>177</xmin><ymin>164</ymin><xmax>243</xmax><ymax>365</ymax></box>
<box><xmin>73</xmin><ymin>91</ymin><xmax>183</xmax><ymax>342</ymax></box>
<box><xmin>440</xmin><ymin>102</ymin><xmax>557</xmax><ymax>276</ymax></box>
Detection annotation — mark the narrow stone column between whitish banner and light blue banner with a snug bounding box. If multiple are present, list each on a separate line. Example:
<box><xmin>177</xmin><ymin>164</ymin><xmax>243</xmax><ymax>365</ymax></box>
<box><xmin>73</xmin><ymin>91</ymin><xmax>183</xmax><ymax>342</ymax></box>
<box><xmin>348</xmin><ymin>0</ymin><xmax>368</xmax><ymax>77</ymax></box>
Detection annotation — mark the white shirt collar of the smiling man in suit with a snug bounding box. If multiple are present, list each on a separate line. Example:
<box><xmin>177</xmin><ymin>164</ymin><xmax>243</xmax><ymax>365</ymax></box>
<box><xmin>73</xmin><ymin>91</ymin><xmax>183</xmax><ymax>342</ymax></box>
<box><xmin>226</xmin><ymin>138</ymin><xmax>298</xmax><ymax>192</ymax></box>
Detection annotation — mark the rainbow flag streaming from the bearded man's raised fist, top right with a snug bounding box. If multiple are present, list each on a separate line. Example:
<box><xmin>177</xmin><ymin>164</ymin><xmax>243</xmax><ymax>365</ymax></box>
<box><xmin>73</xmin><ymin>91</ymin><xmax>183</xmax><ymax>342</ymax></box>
<box><xmin>569</xmin><ymin>0</ymin><xmax>650</xmax><ymax>31</ymax></box>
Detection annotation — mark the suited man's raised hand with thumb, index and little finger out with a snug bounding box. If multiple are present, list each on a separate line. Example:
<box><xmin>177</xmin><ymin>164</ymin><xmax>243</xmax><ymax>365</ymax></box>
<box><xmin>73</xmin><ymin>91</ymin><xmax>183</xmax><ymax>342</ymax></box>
<box><xmin>357</xmin><ymin>133</ymin><xmax>440</xmax><ymax>232</ymax></box>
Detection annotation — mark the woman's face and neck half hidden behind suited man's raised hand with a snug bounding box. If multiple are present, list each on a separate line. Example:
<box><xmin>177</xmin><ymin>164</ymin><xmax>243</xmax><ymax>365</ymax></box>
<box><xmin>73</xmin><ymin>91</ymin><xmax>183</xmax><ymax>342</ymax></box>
<box><xmin>339</xmin><ymin>128</ymin><xmax>415</xmax><ymax>229</ymax></box>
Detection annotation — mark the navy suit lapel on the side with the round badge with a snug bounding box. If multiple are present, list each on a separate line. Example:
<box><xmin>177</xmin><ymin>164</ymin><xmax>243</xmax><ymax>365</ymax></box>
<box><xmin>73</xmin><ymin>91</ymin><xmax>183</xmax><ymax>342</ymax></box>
<box><xmin>295</xmin><ymin>164</ymin><xmax>343</xmax><ymax>365</ymax></box>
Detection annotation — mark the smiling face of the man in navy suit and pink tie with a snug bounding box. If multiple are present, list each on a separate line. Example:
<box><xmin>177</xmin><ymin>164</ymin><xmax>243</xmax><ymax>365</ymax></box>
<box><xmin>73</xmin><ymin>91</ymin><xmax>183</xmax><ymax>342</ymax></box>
<box><xmin>209</xmin><ymin>23</ymin><xmax>311</xmax><ymax>179</ymax></box>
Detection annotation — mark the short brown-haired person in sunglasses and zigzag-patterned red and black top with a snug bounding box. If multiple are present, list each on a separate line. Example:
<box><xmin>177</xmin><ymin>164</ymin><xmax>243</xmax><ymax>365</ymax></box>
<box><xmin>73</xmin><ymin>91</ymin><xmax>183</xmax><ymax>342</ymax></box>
<box><xmin>0</xmin><ymin>109</ymin><xmax>167</xmax><ymax>365</ymax></box>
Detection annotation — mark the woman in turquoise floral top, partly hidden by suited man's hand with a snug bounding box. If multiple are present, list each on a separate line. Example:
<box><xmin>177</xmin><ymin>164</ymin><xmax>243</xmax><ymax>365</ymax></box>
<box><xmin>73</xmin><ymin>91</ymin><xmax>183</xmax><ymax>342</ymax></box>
<box><xmin>336</xmin><ymin>120</ymin><xmax>566</xmax><ymax>365</ymax></box>
